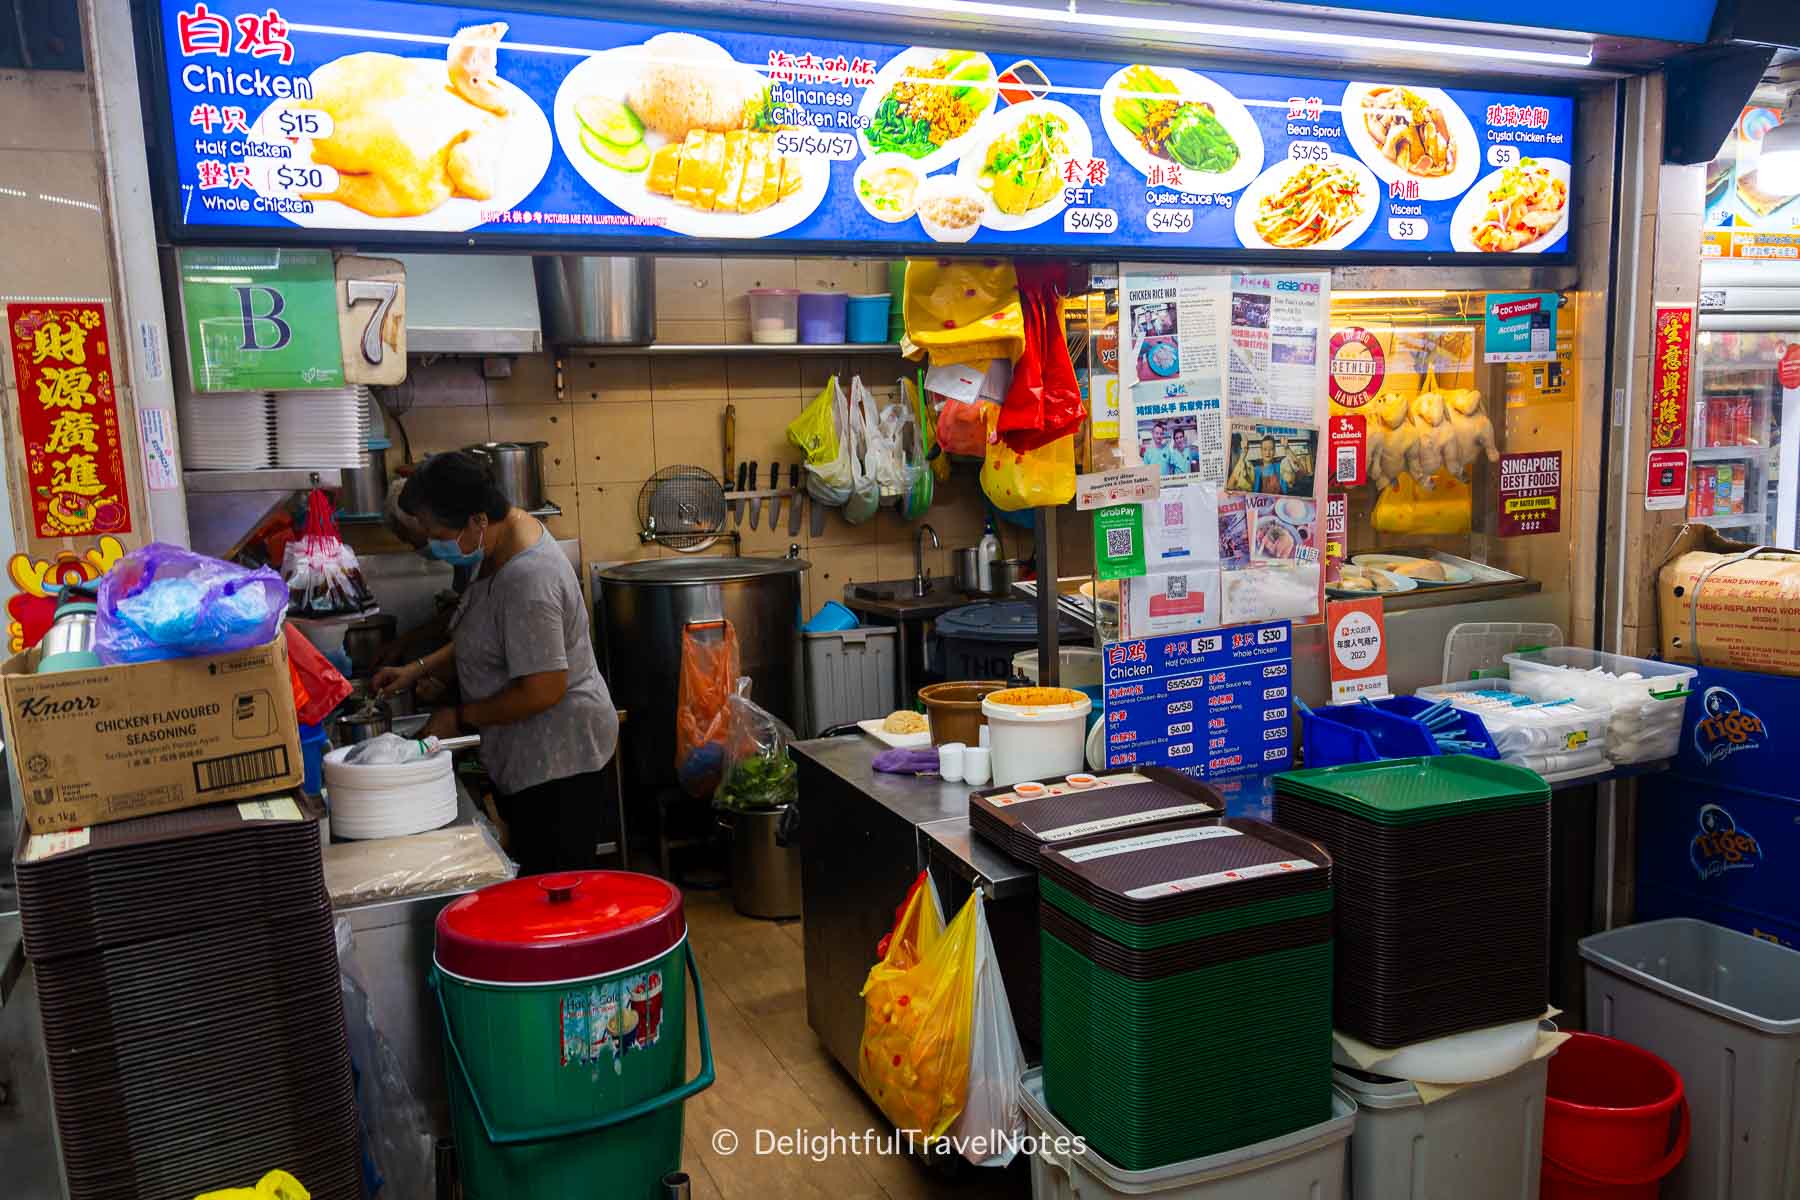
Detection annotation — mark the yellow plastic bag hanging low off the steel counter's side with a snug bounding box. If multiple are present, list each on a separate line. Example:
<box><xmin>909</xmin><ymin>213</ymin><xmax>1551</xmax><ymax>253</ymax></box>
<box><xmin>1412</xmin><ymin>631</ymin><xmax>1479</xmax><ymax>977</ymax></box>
<box><xmin>857</xmin><ymin>880</ymin><xmax>979</xmax><ymax>1137</ymax></box>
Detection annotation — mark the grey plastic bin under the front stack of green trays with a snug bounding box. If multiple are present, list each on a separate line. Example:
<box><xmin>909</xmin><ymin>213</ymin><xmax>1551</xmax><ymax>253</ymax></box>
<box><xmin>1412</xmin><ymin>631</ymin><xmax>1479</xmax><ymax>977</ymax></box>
<box><xmin>1019</xmin><ymin>1067</ymin><xmax>1357</xmax><ymax>1200</ymax></box>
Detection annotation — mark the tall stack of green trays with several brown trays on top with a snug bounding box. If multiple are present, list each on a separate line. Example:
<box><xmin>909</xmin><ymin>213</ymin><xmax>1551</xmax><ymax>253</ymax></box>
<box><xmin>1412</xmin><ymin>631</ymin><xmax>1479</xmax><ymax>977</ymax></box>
<box><xmin>1039</xmin><ymin>819</ymin><xmax>1332</xmax><ymax>1171</ymax></box>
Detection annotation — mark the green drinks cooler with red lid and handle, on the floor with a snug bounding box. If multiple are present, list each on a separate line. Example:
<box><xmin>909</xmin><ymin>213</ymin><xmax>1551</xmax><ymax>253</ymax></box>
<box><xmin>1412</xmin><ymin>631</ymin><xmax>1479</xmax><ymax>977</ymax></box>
<box><xmin>432</xmin><ymin>871</ymin><xmax>713</xmax><ymax>1200</ymax></box>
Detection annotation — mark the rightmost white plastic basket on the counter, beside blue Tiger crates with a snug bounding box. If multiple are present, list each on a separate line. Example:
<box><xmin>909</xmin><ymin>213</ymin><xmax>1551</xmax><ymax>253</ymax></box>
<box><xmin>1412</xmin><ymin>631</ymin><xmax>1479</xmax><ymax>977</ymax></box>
<box><xmin>1507</xmin><ymin>646</ymin><xmax>1697</xmax><ymax>765</ymax></box>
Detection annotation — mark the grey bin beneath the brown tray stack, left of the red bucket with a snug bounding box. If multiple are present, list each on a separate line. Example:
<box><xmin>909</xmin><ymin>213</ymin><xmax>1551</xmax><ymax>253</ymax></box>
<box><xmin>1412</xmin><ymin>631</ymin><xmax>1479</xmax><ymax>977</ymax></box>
<box><xmin>1332</xmin><ymin>1058</ymin><xmax>1550</xmax><ymax>1200</ymax></box>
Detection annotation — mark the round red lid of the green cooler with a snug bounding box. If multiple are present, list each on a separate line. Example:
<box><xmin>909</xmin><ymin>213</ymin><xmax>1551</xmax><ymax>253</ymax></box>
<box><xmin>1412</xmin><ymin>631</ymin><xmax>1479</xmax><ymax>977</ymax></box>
<box><xmin>437</xmin><ymin>871</ymin><xmax>688</xmax><ymax>984</ymax></box>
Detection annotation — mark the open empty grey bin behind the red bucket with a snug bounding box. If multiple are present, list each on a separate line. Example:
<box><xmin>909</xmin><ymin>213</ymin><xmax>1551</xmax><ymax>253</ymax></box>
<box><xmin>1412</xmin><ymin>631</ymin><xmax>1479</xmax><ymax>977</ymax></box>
<box><xmin>1580</xmin><ymin>918</ymin><xmax>1800</xmax><ymax>1200</ymax></box>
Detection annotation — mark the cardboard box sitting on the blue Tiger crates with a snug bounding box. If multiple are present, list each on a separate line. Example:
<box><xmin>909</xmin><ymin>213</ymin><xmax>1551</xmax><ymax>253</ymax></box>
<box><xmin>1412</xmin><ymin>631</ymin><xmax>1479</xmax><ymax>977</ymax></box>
<box><xmin>1656</xmin><ymin>525</ymin><xmax>1800</xmax><ymax>675</ymax></box>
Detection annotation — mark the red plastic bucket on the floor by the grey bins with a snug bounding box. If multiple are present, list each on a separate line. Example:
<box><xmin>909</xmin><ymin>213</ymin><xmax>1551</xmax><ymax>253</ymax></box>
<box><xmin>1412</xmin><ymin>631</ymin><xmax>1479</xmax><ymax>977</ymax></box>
<box><xmin>1543</xmin><ymin>1033</ymin><xmax>1690</xmax><ymax>1200</ymax></box>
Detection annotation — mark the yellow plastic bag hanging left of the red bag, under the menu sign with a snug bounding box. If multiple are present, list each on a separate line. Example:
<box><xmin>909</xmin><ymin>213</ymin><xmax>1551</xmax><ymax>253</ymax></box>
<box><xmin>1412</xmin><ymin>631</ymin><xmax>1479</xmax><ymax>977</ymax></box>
<box><xmin>902</xmin><ymin>259</ymin><xmax>1024</xmax><ymax>367</ymax></box>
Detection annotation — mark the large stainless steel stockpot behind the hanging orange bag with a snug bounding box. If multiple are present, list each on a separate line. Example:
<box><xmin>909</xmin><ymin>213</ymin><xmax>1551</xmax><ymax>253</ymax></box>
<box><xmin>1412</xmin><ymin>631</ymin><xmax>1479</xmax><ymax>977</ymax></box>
<box><xmin>590</xmin><ymin>558</ymin><xmax>810</xmax><ymax>786</ymax></box>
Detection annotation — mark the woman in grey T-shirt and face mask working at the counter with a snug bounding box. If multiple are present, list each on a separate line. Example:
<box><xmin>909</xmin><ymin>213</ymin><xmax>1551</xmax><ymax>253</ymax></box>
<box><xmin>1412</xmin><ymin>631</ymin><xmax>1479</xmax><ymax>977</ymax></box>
<box><xmin>374</xmin><ymin>452</ymin><xmax>619</xmax><ymax>874</ymax></box>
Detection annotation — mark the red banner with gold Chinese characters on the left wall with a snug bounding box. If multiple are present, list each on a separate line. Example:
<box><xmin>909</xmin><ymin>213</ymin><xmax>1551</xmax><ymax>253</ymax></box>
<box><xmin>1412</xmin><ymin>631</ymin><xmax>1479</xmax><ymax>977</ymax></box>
<box><xmin>5</xmin><ymin>304</ymin><xmax>131</xmax><ymax>538</ymax></box>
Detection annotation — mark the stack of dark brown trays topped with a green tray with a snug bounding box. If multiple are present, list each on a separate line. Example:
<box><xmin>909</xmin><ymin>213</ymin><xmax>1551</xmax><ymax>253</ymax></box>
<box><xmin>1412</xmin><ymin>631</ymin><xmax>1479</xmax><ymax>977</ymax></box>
<box><xmin>1274</xmin><ymin>756</ymin><xmax>1550</xmax><ymax>1047</ymax></box>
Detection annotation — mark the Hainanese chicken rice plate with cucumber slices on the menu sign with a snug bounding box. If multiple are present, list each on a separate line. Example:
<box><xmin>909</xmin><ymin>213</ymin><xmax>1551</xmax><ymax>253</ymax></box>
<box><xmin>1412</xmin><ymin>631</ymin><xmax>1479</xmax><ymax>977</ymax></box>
<box><xmin>554</xmin><ymin>32</ymin><xmax>830</xmax><ymax>237</ymax></box>
